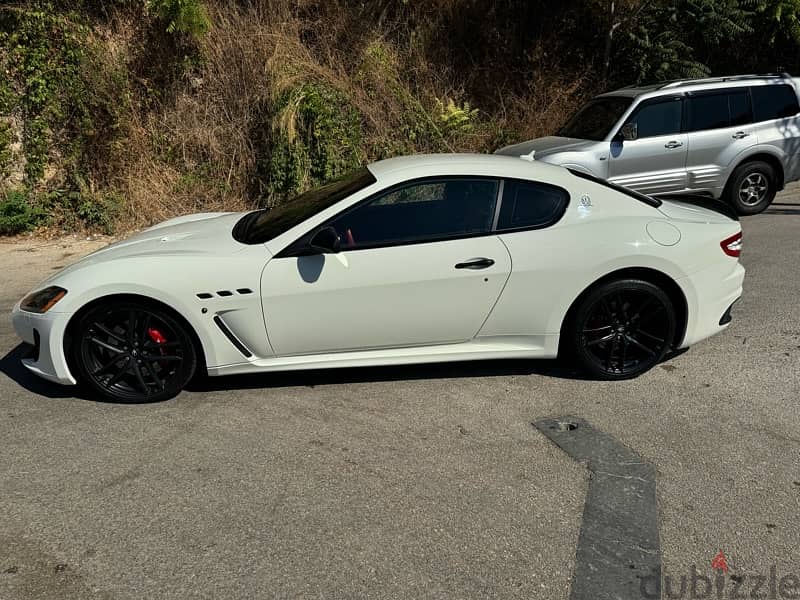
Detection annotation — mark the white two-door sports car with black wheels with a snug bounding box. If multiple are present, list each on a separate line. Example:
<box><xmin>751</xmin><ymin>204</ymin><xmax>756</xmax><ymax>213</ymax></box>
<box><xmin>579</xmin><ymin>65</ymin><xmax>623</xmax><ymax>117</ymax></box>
<box><xmin>13</xmin><ymin>155</ymin><xmax>744</xmax><ymax>402</ymax></box>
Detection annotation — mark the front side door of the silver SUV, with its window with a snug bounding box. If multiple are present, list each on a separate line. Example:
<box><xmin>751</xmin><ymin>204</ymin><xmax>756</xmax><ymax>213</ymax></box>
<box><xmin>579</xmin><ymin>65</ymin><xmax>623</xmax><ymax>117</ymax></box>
<box><xmin>608</xmin><ymin>96</ymin><xmax>687</xmax><ymax>194</ymax></box>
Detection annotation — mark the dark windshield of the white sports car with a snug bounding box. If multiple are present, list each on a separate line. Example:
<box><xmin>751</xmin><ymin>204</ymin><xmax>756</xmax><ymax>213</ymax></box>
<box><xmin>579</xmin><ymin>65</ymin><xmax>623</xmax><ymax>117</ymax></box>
<box><xmin>233</xmin><ymin>167</ymin><xmax>377</xmax><ymax>244</ymax></box>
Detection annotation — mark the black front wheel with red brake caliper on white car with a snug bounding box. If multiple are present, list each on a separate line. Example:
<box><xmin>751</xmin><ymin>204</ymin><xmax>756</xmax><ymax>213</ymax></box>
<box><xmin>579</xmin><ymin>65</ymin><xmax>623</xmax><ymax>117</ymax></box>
<box><xmin>70</xmin><ymin>300</ymin><xmax>197</xmax><ymax>402</ymax></box>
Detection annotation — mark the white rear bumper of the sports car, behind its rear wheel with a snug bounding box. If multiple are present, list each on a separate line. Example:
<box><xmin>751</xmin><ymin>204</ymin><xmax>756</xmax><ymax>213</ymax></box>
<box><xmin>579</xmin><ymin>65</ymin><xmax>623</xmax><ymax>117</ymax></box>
<box><xmin>678</xmin><ymin>259</ymin><xmax>745</xmax><ymax>348</ymax></box>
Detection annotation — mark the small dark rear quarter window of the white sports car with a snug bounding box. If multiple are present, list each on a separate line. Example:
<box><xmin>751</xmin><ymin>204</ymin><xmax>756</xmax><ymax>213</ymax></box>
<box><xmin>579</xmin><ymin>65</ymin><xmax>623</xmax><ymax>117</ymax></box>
<box><xmin>497</xmin><ymin>180</ymin><xmax>569</xmax><ymax>231</ymax></box>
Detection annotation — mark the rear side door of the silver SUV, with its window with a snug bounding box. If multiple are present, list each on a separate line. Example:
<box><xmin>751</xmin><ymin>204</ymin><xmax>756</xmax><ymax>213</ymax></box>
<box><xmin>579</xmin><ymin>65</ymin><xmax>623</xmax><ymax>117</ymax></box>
<box><xmin>684</xmin><ymin>87</ymin><xmax>757</xmax><ymax>196</ymax></box>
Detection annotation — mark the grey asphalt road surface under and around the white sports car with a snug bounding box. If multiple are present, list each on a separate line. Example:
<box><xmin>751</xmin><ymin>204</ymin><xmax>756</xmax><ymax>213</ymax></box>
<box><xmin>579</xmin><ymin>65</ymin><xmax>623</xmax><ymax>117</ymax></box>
<box><xmin>0</xmin><ymin>188</ymin><xmax>800</xmax><ymax>599</ymax></box>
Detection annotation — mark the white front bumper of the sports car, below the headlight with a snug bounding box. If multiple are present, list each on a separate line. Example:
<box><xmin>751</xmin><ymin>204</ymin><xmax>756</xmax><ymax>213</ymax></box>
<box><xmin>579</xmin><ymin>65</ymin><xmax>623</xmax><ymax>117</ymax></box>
<box><xmin>11</xmin><ymin>303</ymin><xmax>77</xmax><ymax>385</ymax></box>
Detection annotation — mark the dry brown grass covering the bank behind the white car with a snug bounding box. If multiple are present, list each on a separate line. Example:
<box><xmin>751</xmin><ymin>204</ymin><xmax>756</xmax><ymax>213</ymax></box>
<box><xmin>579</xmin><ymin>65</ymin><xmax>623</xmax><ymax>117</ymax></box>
<box><xmin>109</xmin><ymin>0</ymin><xmax>590</xmax><ymax>231</ymax></box>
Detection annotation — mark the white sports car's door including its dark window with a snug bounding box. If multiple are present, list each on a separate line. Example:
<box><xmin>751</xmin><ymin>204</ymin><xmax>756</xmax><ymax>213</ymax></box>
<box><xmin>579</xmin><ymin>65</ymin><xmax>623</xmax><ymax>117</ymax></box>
<box><xmin>261</xmin><ymin>178</ymin><xmax>511</xmax><ymax>356</ymax></box>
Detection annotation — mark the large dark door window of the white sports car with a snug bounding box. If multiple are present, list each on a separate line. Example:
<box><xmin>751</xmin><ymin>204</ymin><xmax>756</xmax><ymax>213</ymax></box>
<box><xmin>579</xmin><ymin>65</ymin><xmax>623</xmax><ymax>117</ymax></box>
<box><xmin>329</xmin><ymin>178</ymin><xmax>498</xmax><ymax>249</ymax></box>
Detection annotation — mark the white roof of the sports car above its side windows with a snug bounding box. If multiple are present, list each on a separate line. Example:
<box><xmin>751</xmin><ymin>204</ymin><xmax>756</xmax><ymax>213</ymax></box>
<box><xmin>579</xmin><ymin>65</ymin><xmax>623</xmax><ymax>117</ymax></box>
<box><xmin>368</xmin><ymin>154</ymin><xmax>567</xmax><ymax>181</ymax></box>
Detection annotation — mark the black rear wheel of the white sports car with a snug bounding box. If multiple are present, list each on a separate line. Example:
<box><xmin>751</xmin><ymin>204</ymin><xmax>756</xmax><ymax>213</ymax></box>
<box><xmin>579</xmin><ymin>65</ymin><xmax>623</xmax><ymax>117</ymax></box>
<box><xmin>566</xmin><ymin>279</ymin><xmax>676</xmax><ymax>380</ymax></box>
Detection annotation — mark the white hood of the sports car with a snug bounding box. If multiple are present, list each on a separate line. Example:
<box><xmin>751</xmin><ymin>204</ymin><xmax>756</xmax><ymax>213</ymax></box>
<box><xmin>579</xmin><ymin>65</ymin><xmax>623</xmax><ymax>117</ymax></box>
<box><xmin>52</xmin><ymin>213</ymin><xmax>247</xmax><ymax>276</ymax></box>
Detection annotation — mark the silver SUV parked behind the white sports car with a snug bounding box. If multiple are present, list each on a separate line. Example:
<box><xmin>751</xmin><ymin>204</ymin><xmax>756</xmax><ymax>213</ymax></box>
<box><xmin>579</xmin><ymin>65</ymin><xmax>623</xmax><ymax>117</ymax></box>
<box><xmin>496</xmin><ymin>74</ymin><xmax>800</xmax><ymax>215</ymax></box>
